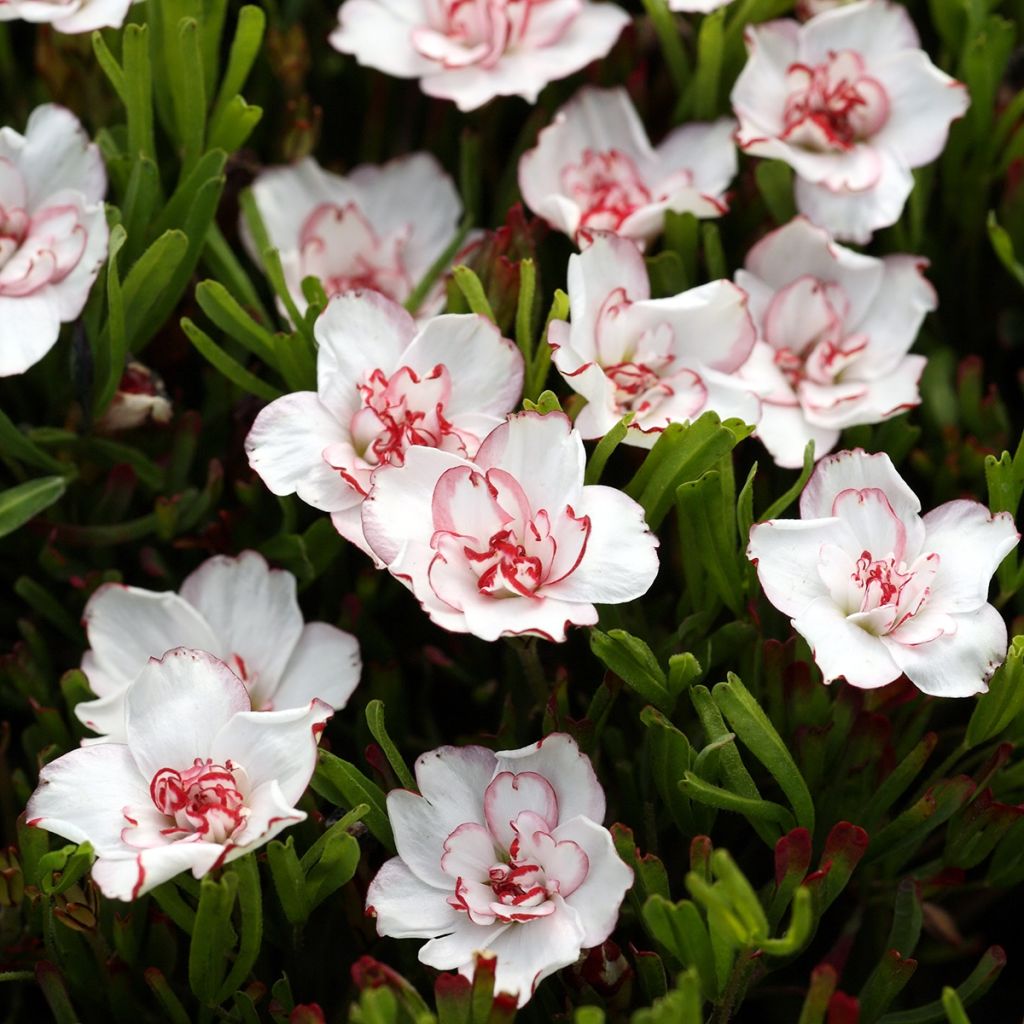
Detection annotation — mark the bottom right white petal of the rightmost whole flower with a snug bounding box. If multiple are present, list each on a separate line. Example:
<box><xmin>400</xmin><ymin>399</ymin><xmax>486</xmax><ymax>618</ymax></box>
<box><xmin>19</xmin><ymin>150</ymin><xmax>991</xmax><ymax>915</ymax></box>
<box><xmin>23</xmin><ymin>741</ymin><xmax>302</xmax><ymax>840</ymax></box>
<box><xmin>886</xmin><ymin>604</ymin><xmax>1007</xmax><ymax>697</ymax></box>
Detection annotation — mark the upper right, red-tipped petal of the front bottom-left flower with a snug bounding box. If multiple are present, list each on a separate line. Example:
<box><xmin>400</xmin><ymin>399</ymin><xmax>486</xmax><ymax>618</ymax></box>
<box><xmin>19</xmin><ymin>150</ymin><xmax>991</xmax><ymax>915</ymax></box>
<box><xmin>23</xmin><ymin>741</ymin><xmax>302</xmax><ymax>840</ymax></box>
<box><xmin>208</xmin><ymin>700</ymin><xmax>333</xmax><ymax>805</ymax></box>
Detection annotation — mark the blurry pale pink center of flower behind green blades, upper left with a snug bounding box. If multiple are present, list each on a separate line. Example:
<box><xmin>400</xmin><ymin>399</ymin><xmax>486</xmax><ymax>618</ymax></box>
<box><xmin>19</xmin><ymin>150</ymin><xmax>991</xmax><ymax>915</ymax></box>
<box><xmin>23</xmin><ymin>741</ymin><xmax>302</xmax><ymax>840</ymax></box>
<box><xmin>299</xmin><ymin>203</ymin><xmax>413</xmax><ymax>302</ymax></box>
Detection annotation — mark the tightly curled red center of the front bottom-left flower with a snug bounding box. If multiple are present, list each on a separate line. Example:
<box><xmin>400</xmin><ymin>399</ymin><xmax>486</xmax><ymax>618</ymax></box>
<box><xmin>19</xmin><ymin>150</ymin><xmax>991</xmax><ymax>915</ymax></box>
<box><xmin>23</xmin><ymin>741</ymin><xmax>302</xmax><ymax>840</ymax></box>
<box><xmin>150</xmin><ymin>758</ymin><xmax>248</xmax><ymax>843</ymax></box>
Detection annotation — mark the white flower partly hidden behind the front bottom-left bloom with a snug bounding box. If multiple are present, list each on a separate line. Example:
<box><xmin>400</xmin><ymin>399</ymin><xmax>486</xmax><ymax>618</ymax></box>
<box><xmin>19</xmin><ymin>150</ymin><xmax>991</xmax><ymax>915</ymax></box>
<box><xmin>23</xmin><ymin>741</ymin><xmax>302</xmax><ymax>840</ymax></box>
<box><xmin>75</xmin><ymin>551</ymin><xmax>361</xmax><ymax>742</ymax></box>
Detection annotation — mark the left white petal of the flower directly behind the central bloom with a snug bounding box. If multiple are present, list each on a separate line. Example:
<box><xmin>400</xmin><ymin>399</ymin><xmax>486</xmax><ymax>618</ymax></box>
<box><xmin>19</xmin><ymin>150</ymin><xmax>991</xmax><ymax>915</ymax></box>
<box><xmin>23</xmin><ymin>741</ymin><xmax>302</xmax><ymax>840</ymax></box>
<box><xmin>246</xmin><ymin>388</ymin><xmax>358</xmax><ymax>512</ymax></box>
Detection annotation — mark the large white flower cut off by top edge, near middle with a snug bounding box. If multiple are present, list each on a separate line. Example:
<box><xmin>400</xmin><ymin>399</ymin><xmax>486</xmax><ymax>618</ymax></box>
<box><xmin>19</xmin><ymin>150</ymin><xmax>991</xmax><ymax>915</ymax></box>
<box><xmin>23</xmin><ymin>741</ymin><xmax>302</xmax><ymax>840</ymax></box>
<box><xmin>330</xmin><ymin>0</ymin><xmax>630</xmax><ymax>111</ymax></box>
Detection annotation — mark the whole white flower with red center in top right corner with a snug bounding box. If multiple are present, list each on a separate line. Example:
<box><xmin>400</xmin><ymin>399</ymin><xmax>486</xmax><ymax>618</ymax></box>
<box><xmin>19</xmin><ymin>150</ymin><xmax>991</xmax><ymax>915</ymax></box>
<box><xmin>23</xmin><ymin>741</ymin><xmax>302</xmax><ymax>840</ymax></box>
<box><xmin>732</xmin><ymin>0</ymin><xmax>968</xmax><ymax>242</ymax></box>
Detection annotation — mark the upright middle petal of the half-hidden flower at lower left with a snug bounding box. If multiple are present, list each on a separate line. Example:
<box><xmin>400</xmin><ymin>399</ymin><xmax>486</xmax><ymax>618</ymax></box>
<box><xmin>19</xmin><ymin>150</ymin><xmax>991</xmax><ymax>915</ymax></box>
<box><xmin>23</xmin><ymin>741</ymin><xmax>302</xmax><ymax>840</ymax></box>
<box><xmin>181</xmin><ymin>551</ymin><xmax>302</xmax><ymax>707</ymax></box>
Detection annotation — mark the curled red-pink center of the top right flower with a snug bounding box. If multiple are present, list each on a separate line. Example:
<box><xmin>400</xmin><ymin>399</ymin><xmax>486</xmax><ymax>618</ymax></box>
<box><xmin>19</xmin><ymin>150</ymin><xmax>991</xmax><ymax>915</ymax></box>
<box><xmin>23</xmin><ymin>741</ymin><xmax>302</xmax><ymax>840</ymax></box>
<box><xmin>782</xmin><ymin>50</ymin><xmax>889</xmax><ymax>153</ymax></box>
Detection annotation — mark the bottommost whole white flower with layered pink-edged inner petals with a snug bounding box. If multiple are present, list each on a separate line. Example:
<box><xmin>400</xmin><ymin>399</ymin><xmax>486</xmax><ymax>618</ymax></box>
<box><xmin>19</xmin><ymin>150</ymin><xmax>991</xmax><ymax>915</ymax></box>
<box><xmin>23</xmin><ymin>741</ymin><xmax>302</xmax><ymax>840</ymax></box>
<box><xmin>367</xmin><ymin>733</ymin><xmax>633</xmax><ymax>1006</ymax></box>
